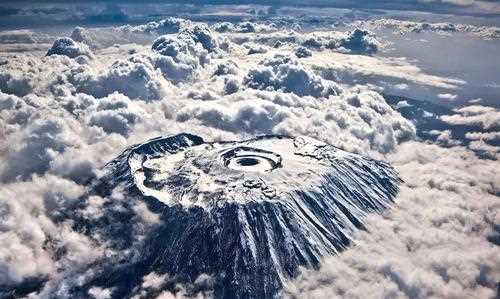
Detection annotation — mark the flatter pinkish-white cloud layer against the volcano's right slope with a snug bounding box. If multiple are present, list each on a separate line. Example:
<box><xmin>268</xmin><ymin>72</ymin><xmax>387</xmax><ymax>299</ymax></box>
<box><xmin>285</xmin><ymin>142</ymin><xmax>500</xmax><ymax>298</ymax></box>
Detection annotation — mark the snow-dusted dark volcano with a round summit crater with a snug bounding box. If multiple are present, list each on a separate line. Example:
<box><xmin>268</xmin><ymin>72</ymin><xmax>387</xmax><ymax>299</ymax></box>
<box><xmin>95</xmin><ymin>134</ymin><xmax>401</xmax><ymax>298</ymax></box>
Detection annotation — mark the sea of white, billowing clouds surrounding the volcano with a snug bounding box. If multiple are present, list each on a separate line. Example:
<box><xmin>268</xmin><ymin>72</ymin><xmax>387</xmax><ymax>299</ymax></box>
<box><xmin>0</xmin><ymin>8</ymin><xmax>500</xmax><ymax>298</ymax></box>
